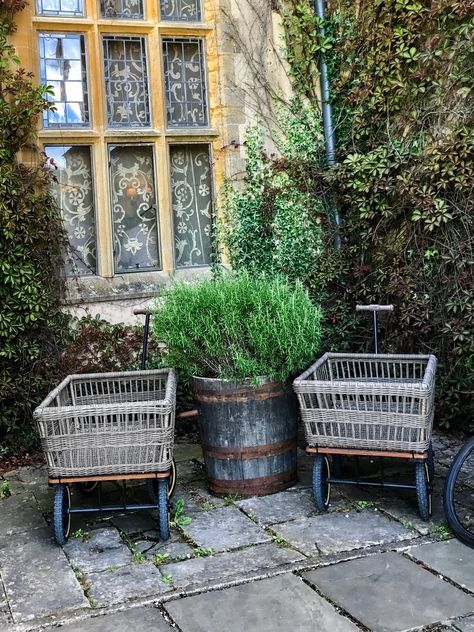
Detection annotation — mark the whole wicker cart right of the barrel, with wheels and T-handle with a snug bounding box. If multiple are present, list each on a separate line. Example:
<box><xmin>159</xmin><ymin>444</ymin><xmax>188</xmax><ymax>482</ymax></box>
<box><xmin>293</xmin><ymin>305</ymin><xmax>437</xmax><ymax>520</ymax></box>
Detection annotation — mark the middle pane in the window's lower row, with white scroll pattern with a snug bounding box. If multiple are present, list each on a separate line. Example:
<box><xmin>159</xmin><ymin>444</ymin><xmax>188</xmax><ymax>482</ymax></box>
<box><xmin>110</xmin><ymin>145</ymin><xmax>160</xmax><ymax>272</ymax></box>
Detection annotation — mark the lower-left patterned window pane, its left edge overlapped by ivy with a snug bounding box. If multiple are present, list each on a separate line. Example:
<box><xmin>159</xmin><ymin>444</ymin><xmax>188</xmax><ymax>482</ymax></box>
<box><xmin>45</xmin><ymin>145</ymin><xmax>97</xmax><ymax>276</ymax></box>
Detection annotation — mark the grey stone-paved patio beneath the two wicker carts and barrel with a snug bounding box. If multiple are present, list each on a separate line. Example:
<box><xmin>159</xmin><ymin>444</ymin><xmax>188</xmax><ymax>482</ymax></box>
<box><xmin>0</xmin><ymin>435</ymin><xmax>474</xmax><ymax>632</ymax></box>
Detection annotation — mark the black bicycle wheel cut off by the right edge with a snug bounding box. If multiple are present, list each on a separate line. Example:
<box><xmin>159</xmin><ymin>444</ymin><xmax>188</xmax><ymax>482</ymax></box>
<box><xmin>443</xmin><ymin>437</ymin><xmax>474</xmax><ymax>548</ymax></box>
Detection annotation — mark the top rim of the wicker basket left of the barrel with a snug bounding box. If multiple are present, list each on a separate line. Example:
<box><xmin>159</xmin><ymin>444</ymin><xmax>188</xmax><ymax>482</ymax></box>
<box><xmin>33</xmin><ymin>368</ymin><xmax>176</xmax><ymax>421</ymax></box>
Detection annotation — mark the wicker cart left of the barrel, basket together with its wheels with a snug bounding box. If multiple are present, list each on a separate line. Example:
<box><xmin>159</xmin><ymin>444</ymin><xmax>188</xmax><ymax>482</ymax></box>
<box><xmin>34</xmin><ymin>369</ymin><xmax>176</xmax><ymax>544</ymax></box>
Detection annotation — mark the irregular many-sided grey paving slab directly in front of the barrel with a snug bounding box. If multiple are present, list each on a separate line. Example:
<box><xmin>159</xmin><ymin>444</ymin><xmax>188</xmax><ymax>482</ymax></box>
<box><xmin>184</xmin><ymin>507</ymin><xmax>270</xmax><ymax>552</ymax></box>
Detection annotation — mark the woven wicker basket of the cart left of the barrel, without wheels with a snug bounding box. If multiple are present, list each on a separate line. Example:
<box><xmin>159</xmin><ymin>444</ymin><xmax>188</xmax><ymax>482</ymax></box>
<box><xmin>34</xmin><ymin>369</ymin><xmax>176</xmax><ymax>477</ymax></box>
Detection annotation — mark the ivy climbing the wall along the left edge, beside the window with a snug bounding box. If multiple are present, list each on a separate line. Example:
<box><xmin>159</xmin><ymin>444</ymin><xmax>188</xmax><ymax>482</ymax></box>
<box><xmin>0</xmin><ymin>1</ymin><xmax>65</xmax><ymax>453</ymax></box>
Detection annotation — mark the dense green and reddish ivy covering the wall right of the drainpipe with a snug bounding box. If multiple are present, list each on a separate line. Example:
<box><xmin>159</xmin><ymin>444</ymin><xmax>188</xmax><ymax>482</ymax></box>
<box><xmin>283</xmin><ymin>0</ymin><xmax>474</xmax><ymax>429</ymax></box>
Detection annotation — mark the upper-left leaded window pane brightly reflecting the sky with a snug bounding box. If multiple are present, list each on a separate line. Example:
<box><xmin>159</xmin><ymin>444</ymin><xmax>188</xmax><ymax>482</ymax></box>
<box><xmin>39</xmin><ymin>33</ymin><xmax>89</xmax><ymax>127</ymax></box>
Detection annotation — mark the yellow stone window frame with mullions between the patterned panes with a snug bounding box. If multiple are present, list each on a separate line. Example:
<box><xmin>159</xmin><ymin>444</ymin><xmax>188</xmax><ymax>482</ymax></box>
<box><xmin>32</xmin><ymin>0</ymin><xmax>222</xmax><ymax>287</ymax></box>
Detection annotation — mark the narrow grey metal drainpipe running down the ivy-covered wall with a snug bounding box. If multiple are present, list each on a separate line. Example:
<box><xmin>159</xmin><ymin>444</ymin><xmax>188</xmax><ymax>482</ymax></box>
<box><xmin>314</xmin><ymin>0</ymin><xmax>341</xmax><ymax>250</ymax></box>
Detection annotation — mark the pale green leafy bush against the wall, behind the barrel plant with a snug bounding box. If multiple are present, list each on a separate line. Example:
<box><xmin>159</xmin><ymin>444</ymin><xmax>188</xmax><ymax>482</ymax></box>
<box><xmin>219</xmin><ymin>99</ymin><xmax>326</xmax><ymax>287</ymax></box>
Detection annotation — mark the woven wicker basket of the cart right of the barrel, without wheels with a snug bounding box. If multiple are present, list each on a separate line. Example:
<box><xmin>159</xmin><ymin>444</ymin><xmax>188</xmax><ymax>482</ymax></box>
<box><xmin>293</xmin><ymin>353</ymin><xmax>437</xmax><ymax>453</ymax></box>
